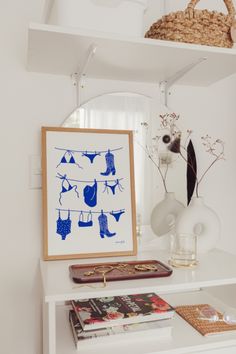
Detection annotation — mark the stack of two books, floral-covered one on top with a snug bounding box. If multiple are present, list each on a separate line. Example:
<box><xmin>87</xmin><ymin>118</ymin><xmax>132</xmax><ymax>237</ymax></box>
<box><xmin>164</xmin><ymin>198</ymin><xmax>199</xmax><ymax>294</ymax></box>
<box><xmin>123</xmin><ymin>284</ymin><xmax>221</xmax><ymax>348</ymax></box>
<box><xmin>69</xmin><ymin>293</ymin><xmax>174</xmax><ymax>349</ymax></box>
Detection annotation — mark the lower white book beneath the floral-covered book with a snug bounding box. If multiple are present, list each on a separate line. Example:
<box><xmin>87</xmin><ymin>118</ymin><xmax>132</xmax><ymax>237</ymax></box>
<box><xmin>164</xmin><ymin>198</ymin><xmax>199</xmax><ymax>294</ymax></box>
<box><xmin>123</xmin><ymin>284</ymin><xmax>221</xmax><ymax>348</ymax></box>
<box><xmin>69</xmin><ymin>310</ymin><xmax>172</xmax><ymax>349</ymax></box>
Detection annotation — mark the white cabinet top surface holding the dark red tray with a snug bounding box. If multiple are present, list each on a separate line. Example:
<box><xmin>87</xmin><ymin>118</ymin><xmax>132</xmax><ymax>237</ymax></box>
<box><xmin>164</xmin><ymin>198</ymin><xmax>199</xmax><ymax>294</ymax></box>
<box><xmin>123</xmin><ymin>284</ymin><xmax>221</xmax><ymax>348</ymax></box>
<box><xmin>41</xmin><ymin>250</ymin><xmax>236</xmax><ymax>302</ymax></box>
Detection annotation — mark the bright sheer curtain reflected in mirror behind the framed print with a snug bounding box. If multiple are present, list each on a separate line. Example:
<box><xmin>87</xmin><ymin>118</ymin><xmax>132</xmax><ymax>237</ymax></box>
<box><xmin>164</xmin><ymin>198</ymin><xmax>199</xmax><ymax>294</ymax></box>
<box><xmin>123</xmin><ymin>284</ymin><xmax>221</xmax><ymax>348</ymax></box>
<box><xmin>63</xmin><ymin>92</ymin><xmax>156</xmax><ymax>224</ymax></box>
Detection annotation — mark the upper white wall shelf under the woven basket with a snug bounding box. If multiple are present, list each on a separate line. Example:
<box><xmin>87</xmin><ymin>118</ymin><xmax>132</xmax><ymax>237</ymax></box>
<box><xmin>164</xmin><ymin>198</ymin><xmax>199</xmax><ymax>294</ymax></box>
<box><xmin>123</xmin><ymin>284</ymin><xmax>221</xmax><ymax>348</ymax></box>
<box><xmin>28</xmin><ymin>23</ymin><xmax>236</xmax><ymax>86</ymax></box>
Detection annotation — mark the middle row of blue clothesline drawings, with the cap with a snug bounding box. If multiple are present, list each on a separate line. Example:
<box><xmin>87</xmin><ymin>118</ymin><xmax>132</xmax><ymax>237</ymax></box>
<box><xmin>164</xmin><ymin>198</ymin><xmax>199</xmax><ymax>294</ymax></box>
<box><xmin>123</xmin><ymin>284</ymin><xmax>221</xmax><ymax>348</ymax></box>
<box><xmin>56</xmin><ymin>173</ymin><xmax>124</xmax><ymax>207</ymax></box>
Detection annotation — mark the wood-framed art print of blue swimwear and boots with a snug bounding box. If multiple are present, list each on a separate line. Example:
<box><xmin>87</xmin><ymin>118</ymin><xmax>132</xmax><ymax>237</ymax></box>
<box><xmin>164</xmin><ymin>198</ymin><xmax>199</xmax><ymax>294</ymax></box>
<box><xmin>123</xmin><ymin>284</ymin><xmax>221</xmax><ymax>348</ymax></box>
<box><xmin>42</xmin><ymin>127</ymin><xmax>137</xmax><ymax>260</ymax></box>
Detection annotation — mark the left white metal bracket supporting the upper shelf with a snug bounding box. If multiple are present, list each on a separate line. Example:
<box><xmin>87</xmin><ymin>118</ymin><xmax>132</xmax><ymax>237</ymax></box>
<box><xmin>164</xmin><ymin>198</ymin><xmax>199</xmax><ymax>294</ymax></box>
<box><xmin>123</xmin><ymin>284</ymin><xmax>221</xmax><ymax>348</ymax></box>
<box><xmin>71</xmin><ymin>44</ymin><xmax>97</xmax><ymax>108</ymax></box>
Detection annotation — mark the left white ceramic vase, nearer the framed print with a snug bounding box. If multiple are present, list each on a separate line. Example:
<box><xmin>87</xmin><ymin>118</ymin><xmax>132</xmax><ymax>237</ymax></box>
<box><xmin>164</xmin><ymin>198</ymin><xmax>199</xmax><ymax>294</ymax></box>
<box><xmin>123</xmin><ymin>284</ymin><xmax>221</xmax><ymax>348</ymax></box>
<box><xmin>151</xmin><ymin>193</ymin><xmax>184</xmax><ymax>236</ymax></box>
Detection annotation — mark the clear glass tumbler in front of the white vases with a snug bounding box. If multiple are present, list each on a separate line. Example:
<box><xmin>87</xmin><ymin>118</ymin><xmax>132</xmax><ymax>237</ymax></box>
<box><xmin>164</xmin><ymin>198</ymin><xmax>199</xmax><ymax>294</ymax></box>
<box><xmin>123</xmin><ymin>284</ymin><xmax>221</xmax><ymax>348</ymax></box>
<box><xmin>169</xmin><ymin>233</ymin><xmax>197</xmax><ymax>268</ymax></box>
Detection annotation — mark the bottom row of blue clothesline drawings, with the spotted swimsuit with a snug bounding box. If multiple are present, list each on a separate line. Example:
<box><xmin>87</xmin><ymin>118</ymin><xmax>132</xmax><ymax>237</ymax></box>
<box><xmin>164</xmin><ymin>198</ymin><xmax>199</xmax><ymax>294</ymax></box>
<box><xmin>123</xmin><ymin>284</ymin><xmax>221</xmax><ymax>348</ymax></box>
<box><xmin>56</xmin><ymin>208</ymin><xmax>125</xmax><ymax>240</ymax></box>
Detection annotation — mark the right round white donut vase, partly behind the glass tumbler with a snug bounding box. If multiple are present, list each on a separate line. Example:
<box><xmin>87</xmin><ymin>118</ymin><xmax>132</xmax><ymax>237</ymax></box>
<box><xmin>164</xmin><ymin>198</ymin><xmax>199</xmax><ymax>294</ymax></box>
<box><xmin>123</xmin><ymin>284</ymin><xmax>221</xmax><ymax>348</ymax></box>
<box><xmin>175</xmin><ymin>197</ymin><xmax>220</xmax><ymax>253</ymax></box>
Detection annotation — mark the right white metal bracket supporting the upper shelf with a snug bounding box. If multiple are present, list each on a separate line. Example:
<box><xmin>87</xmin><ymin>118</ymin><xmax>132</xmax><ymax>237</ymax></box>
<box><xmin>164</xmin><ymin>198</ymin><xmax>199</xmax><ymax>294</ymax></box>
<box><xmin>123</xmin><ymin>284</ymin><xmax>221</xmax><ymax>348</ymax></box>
<box><xmin>159</xmin><ymin>57</ymin><xmax>207</xmax><ymax>107</ymax></box>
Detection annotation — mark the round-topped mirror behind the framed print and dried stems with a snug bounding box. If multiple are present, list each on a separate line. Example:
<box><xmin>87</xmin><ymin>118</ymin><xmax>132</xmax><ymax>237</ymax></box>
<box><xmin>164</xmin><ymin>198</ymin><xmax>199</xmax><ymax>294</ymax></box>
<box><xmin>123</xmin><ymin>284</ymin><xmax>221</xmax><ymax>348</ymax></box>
<box><xmin>63</xmin><ymin>92</ymin><xmax>185</xmax><ymax>242</ymax></box>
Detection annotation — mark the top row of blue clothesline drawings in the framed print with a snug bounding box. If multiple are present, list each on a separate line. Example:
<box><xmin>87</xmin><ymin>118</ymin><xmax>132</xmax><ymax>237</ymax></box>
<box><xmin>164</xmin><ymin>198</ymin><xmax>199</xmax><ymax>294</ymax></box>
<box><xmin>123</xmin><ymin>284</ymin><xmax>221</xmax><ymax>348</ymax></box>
<box><xmin>55</xmin><ymin>147</ymin><xmax>123</xmax><ymax>176</ymax></box>
